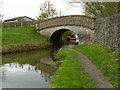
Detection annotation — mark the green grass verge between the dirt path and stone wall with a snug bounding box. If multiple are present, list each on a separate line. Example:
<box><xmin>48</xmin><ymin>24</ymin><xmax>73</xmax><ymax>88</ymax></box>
<box><xmin>75</xmin><ymin>45</ymin><xmax>119</xmax><ymax>88</ymax></box>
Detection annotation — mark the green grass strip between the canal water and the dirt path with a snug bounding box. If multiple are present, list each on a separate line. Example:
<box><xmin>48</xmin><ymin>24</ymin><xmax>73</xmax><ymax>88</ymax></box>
<box><xmin>52</xmin><ymin>49</ymin><xmax>97</xmax><ymax>88</ymax></box>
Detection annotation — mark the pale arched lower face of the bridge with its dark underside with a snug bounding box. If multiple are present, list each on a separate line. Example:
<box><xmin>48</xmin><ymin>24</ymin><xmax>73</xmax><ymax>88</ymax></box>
<box><xmin>40</xmin><ymin>26</ymin><xmax>94</xmax><ymax>46</ymax></box>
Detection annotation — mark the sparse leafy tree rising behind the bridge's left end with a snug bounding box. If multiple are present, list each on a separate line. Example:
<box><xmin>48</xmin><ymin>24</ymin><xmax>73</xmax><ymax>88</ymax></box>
<box><xmin>37</xmin><ymin>0</ymin><xmax>57</xmax><ymax>21</ymax></box>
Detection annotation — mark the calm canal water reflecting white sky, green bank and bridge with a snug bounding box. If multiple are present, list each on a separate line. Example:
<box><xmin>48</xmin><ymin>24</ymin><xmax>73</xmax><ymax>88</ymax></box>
<box><xmin>0</xmin><ymin>50</ymin><xmax>57</xmax><ymax>88</ymax></box>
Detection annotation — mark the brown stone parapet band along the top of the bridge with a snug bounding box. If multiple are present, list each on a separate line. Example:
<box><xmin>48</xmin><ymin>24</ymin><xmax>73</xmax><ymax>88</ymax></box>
<box><xmin>39</xmin><ymin>15</ymin><xmax>94</xmax><ymax>30</ymax></box>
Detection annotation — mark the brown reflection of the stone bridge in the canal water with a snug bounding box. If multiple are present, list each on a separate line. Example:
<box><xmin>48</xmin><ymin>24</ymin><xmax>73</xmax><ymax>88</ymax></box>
<box><xmin>35</xmin><ymin>56</ymin><xmax>57</xmax><ymax>82</ymax></box>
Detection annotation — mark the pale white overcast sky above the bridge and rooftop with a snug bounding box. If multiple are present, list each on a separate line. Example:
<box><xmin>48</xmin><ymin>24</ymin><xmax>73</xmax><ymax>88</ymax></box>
<box><xmin>0</xmin><ymin>0</ymin><xmax>83</xmax><ymax>20</ymax></box>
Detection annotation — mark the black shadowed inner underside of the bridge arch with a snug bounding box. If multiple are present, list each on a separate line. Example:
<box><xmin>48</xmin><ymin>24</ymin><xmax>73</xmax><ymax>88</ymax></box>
<box><xmin>50</xmin><ymin>29</ymin><xmax>70</xmax><ymax>48</ymax></box>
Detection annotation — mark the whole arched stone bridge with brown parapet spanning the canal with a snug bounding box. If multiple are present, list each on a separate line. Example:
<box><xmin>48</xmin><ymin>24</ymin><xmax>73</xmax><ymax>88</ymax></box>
<box><xmin>37</xmin><ymin>15</ymin><xmax>94</xmax><ymax>45</ymax></box>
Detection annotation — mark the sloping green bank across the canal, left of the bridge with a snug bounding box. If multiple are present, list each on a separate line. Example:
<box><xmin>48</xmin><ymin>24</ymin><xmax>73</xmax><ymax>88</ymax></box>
<box><xmin>2</xmin><ymin>27</ymin><xmax>50</xmax><ymax>53</ymax></box>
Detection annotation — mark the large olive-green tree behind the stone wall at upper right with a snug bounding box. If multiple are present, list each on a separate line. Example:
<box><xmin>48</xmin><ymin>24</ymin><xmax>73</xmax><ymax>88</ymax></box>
<box><xmin>70</xmin><ymin>0</ymin><xmax>118</xmax><ymax>17</ymax></box>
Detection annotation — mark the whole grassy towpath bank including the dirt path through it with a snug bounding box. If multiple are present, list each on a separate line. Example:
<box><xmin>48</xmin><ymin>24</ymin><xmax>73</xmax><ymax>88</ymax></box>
<box><xmin>51</xmin><ymin>44</ymin><xmax>119</xmax><ymax>88</ymax></box>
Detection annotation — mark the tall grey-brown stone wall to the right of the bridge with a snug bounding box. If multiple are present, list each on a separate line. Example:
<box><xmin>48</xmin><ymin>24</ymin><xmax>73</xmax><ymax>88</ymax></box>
<box><xmin>94</xmin><ymin>14</ymin><xmax>120</xmax><ymax>51</ymax></box>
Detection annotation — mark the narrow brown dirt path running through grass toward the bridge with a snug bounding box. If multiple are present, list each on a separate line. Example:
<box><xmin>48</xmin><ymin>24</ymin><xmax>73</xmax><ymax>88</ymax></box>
<box><xmin>65</xmin><ymin>46</ymin><xmax>113</xmax><ymax>88</ymax></box>
